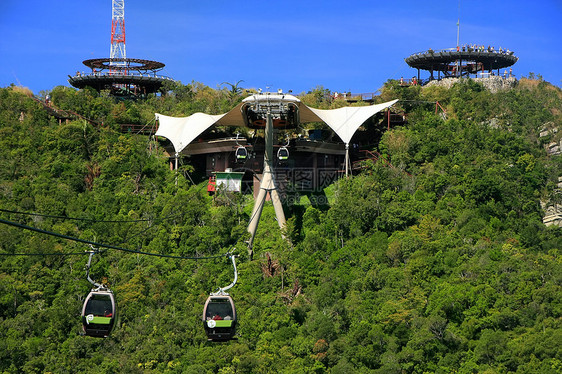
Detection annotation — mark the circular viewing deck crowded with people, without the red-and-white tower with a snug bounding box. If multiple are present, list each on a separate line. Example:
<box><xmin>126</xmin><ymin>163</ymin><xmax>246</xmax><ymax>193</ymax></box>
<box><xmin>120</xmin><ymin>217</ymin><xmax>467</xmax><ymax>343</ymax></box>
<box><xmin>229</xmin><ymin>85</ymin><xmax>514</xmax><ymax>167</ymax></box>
<box><xmin>404</xmin><ymin>46</ymin><xmax>518</xmax><ymax>80</ymax></box>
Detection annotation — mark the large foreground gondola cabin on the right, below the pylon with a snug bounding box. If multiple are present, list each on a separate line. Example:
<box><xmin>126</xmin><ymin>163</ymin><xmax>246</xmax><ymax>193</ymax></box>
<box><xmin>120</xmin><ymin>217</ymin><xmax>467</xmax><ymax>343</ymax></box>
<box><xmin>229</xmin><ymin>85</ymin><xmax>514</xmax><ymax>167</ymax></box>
<box><xmin>203</xmin><ymin>295</ymin><xmax>236</xmax><ymax>341</ymax></box>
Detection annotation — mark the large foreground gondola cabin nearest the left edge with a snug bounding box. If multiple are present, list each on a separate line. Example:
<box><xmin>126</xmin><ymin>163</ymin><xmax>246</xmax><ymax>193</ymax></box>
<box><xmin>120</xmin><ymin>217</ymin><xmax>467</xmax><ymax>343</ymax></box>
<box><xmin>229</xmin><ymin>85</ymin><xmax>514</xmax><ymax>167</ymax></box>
<box><xmin>82</xmin><ymin>290</ymin><xmax>117</xmax><ymax>338</ymax></box>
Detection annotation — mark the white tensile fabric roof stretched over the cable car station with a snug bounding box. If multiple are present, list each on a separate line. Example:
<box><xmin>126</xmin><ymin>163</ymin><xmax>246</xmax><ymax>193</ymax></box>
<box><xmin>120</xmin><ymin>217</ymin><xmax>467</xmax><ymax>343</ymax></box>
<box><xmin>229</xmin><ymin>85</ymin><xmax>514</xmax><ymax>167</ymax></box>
<box><xmin>156</xmin><ymin>93</ymin><xmax>398</xmax><ymax>153</ymax></box>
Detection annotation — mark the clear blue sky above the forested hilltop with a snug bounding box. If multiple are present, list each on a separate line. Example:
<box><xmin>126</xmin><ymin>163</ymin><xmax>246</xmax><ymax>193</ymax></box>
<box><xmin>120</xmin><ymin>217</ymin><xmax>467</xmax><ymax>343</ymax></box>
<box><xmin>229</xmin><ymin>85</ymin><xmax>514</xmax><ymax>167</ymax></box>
<box><xmin>0</xmin><ymin>0</ymin><xmax>562</xmax><ymax>94</ymax></box>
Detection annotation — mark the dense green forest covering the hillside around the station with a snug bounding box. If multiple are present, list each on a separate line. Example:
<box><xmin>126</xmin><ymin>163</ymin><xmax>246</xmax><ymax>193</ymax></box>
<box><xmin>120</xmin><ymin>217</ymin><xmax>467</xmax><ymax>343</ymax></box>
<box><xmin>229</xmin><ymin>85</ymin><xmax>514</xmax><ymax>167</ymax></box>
<box><xmin>0</xmin><ymin>75</ymin><xmax>562</xmax><ymax>374</ymax></box>
